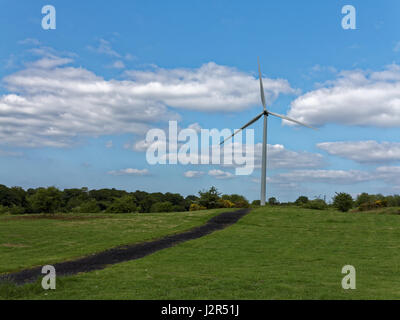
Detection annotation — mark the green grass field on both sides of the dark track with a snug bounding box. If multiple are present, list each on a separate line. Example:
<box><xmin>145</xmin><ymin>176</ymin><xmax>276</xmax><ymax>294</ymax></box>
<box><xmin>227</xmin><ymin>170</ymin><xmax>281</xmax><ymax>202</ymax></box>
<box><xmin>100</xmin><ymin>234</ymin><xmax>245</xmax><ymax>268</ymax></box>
<box><xmin>0</xmin><ymin>207</ymin><xmax>400</xmax><ymax>299</ymax></box>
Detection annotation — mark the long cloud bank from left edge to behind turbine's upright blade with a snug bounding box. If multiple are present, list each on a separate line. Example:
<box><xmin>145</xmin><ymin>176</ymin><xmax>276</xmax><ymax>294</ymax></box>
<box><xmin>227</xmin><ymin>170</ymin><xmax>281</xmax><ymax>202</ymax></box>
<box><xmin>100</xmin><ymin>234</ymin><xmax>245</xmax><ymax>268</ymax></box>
<box><xmin>0</xmin><ymin>55</ymin><xmax>295</xmax><ymax>147</ymax></box>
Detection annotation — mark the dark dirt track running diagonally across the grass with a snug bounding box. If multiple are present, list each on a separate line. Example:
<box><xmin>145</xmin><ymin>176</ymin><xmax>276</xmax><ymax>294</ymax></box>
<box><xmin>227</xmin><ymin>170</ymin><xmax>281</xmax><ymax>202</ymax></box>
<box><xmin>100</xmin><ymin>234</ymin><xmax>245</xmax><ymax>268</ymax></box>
<box><xmin>0</xmin><ymin>209</ymin><xmax>250</xmax><ymax>284</ymax></box>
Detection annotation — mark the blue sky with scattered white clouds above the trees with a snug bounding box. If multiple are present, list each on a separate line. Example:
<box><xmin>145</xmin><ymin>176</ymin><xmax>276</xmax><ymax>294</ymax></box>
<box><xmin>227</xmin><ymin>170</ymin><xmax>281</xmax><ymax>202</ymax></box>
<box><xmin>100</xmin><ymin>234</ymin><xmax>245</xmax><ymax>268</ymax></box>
<box><xmin>0</xmin><ymin>0</ymin><xmax>400</xmax><ymax>201</ymax></box>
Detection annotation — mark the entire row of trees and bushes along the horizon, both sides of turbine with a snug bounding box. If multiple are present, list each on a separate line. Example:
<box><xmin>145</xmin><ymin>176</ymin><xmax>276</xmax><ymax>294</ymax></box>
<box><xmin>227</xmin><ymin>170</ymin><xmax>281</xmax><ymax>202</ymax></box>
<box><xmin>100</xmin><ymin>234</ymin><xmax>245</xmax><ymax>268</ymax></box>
<box><xmin>0</xmin><ymin>184</ymin><xmax>400</xmax><ymax>214</ymax></box>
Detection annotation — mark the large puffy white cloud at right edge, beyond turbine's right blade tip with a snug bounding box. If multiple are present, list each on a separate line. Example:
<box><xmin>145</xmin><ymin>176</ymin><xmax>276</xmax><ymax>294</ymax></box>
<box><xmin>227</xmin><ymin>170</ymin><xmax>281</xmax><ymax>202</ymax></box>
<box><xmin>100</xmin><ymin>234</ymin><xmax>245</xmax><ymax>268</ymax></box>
<box><xmin>285</xmin><ymin>64</ymin><xmax>400</xmax><ymax>127</ymax></box>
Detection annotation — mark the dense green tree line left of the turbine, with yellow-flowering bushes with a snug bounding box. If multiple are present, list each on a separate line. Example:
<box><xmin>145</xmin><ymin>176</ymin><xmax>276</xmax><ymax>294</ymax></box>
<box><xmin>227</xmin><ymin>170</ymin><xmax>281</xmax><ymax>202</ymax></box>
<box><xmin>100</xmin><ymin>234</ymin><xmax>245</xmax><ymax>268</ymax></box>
<box><xmin>0</xmin><ymin>185</ymin><xmax>249</xmax><ymax>214</ymax></box>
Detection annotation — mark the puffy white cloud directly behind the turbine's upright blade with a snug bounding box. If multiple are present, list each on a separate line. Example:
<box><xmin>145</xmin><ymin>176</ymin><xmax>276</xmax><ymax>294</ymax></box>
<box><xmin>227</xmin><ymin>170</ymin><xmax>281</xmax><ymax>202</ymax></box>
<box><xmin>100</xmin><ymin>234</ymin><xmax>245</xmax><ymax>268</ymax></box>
<box><xmin>125</xmin><ymin>62</ymin><xmax>297</xmax><ymax>112</ymax></box>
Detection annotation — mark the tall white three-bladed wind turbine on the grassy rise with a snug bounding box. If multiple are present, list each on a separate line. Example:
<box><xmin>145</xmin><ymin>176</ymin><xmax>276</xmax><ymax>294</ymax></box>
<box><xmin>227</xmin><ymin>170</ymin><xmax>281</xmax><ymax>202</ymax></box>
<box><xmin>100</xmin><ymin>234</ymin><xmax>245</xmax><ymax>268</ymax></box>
<box><xmin>220</xmin><ymin>59</ymin><xmax>315</xmax><ymax>206</ymax></box>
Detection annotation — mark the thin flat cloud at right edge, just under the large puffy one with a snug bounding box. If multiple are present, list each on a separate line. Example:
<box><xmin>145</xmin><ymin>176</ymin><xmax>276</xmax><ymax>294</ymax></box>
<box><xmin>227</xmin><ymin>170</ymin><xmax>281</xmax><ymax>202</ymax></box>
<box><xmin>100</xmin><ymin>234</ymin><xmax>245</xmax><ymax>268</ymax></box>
<box><xmin>317</xmin><ymin>140</ymin><xmax>400</xmax><ymax>163</ymax></box>
